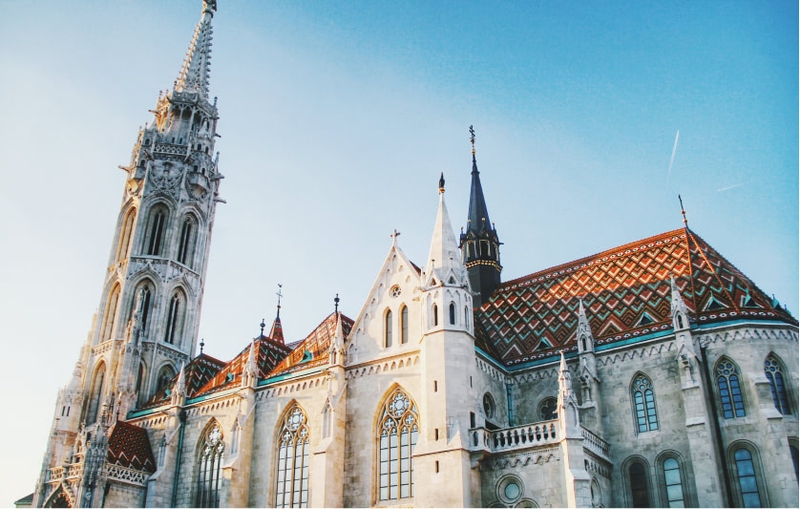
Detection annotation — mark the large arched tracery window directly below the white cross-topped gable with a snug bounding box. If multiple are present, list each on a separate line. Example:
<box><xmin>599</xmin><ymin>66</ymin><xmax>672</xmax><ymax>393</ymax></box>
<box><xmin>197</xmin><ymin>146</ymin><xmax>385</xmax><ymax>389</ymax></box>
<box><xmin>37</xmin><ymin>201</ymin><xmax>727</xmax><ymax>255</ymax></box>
<box><xmin>377</xmin><ymin>388</ymin><xmax>419</xmax><ymax>500</ymax></box>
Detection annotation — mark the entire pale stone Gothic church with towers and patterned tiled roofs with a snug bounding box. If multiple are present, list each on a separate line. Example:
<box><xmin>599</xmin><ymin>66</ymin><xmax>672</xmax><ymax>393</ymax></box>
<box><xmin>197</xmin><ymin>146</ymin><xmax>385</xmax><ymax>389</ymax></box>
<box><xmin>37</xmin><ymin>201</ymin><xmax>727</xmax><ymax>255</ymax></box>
<box><xmin>32</xmin><ymin>0</ymin><xmax>800</xmax><ymax>507</ymax></box>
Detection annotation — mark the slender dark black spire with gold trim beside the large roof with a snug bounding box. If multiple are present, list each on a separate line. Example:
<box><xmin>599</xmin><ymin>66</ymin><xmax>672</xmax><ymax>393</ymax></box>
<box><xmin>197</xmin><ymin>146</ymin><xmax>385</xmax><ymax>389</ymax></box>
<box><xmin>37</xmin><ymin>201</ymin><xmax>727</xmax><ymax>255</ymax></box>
<box><xmin>460</xmin><ymin>126</ymin><xmax>503</xmax><ymax>306</ymax></box>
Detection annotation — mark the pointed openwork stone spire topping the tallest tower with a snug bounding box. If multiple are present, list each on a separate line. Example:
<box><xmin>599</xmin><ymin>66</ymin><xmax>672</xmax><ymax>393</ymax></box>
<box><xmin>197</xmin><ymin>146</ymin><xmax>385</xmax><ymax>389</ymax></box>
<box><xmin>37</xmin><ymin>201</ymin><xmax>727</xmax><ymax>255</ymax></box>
<box><xmin>174</xmin><ymin>0</ymin><xmax>217</xmax><ymax>99</ymax></box>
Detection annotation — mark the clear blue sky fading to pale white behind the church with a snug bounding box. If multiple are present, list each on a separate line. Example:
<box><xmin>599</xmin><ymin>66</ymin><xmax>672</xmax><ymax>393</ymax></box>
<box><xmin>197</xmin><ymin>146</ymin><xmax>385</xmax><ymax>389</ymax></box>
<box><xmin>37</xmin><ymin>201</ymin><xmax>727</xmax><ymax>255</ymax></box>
<box><xmin>0</xmin><ymin>0</ymin><xmax>798</xmax><ymax>505</ymax></box>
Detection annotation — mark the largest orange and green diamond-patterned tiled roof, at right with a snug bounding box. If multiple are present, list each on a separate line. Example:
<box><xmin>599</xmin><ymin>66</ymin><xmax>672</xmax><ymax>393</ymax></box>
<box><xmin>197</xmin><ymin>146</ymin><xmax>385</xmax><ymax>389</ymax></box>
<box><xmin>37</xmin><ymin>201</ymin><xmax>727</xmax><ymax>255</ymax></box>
<box><xmin>476</xmin><ymin>228</ymin><xmax>797</xmax><ymax>366</ymax></box>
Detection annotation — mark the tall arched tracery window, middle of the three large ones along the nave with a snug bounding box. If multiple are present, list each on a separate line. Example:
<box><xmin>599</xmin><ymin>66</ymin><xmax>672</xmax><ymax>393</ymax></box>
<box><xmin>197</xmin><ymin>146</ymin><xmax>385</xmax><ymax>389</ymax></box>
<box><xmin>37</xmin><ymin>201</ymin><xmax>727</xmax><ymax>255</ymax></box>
<box><xmin>275</xmin><ymin>405</ymin><xmax>309</xmax><ymax>507</ymax></box>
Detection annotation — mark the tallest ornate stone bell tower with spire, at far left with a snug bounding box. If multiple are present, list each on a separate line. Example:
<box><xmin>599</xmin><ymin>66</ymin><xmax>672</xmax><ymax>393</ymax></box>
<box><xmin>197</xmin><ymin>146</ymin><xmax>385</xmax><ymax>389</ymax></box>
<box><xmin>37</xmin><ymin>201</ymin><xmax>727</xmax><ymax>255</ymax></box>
<box><xmin>34</xmin><ymin>0</ymin><xmax>223</xmax><ymax>506</ymax></box>
